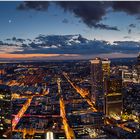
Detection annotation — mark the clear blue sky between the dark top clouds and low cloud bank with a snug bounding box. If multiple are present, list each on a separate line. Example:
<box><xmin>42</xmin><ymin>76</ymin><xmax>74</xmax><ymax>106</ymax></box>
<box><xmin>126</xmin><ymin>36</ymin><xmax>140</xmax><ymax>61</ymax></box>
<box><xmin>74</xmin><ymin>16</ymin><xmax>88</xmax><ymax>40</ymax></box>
<box><xmin>0</xmin><ymin>2</ymin><xmax>140</xmax><ymax>42</ymax></box>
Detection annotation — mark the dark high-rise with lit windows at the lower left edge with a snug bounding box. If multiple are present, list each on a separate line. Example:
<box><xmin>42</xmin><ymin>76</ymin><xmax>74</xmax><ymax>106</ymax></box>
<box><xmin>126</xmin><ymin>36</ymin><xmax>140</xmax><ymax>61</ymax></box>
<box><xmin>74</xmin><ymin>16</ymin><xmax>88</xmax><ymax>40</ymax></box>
<box><xmin>0</xmin><ymin>84</ymin><xmax>12</xmax><ymax>139</ymax></box>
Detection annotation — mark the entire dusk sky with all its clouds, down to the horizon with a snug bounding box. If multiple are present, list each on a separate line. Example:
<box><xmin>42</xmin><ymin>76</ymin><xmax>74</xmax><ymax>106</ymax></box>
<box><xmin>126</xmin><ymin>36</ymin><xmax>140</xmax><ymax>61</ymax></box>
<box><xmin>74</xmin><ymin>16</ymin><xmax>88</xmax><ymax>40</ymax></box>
<box><xmin>0</xmin><ymin>1</ymin><xmax>140</xmax><ymax>59</ymax></box>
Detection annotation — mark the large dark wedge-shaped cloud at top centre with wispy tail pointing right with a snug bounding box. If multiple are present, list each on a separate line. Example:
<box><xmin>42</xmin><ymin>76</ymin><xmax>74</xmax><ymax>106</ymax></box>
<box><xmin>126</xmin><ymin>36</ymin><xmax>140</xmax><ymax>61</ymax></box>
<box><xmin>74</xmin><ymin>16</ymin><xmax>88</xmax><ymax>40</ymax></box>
<box><xmin>56</xmin><ymin>1</ymin><xmax>119</xmax><ymax>31</ymax></box>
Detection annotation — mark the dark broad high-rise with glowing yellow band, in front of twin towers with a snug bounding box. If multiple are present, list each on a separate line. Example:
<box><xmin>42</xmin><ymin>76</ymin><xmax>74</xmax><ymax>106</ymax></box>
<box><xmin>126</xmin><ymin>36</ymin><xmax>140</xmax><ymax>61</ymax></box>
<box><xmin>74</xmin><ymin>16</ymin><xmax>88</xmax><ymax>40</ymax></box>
<box><xmin>104</xmin><ymin>77</ymin><xmax>123</xmax><ymax>116</ymax></box>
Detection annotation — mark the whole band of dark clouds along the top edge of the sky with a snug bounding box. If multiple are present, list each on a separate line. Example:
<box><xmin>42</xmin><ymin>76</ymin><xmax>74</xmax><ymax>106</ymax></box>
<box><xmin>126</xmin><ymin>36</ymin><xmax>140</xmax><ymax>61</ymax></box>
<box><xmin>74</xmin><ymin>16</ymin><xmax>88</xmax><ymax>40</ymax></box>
<box><xmin>17</xmin><ymin>1</ymin><xmax>140</xmax><ymax>31</ymax></box>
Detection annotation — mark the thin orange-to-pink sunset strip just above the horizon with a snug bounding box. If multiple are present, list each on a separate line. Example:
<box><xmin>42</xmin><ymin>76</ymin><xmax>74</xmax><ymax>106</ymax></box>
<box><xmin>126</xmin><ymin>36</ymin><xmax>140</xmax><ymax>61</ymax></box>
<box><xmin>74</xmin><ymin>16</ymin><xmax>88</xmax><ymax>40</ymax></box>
<box><xmin>0</xmin><ymin>53</ymin><xmax>136</xmax><ymax>61</ymax></box>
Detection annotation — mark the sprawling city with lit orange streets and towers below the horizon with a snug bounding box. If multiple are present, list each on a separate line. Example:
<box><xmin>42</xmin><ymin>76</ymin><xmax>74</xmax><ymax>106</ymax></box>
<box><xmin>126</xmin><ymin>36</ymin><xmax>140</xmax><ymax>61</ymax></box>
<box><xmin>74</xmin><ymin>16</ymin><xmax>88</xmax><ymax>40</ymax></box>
<box><xmin>0</xmin><ymin>55</ymin><xmax>140</xmax><ymax>139</ymax></box>
